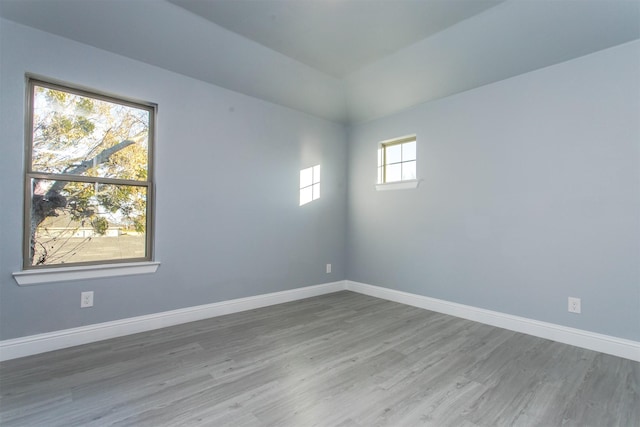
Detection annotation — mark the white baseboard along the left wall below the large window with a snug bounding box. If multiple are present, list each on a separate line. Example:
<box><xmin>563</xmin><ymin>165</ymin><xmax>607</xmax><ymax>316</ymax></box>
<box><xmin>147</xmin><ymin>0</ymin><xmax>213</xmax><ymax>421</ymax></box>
<box><xmin>0</xmin><ymin>281</ymin><xmax>345</xmax><ymax>361</ymax></box>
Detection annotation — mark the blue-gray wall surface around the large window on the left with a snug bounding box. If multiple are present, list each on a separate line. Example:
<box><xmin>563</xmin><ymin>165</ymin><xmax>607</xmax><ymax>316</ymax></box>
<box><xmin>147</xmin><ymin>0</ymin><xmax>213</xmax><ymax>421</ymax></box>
<box><xmin>0</xmin><ymin>20</ymin><xmax>347</xmax><ymax>340</ymax></box>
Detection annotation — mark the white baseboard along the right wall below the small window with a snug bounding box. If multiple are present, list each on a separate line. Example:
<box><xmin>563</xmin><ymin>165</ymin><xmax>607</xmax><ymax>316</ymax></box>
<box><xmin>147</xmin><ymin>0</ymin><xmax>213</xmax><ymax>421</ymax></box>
<box><xmin>345</xmin><ymin>280</ymin><xmax>640</xmax><ymax>362</ymax></box>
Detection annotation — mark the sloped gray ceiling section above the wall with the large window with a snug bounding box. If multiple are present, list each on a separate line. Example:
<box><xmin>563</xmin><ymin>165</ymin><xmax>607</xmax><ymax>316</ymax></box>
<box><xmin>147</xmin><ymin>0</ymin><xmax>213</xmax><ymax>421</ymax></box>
<box><xmin>0</xmin><ymin>0</ymin><xmax>346</xmax><ymax>121</ymax></box>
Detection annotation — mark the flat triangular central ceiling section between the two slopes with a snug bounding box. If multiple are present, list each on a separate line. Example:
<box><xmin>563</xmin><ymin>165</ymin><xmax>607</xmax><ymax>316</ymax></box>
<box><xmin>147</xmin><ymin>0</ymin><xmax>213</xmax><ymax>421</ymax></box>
<box><xmin>168</xmin><ymin>0</ymin><xmax>504</xmax><ymax>78</ymax></box>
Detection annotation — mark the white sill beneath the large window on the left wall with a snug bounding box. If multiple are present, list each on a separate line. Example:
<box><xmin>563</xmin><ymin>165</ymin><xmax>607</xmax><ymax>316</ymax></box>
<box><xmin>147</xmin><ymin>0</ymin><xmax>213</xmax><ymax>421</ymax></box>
<box><xmin>13</xmin><ymin>262</ymin><xmax>160</xmax><ymax>286</ymax></box>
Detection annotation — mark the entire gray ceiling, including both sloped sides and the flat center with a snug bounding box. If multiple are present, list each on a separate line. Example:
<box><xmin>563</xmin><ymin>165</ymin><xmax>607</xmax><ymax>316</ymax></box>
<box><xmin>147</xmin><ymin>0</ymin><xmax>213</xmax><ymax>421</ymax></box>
<box><xmin>0</xmin><ymin>0</ymin><xmax>640</xmax><ymax>123</ymax></box>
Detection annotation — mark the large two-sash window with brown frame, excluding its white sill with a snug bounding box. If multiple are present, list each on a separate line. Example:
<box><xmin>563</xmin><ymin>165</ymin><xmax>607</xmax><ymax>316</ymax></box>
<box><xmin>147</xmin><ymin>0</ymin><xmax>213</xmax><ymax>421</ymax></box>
<box><xmin>24</xmin><ymin>79</ymin><xmax>155</xmax><ymax>269</ymax></box>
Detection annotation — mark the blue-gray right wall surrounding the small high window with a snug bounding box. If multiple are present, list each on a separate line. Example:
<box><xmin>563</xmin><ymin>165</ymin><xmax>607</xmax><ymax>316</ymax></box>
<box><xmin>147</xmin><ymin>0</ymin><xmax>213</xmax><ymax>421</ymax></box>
<box><xmin>347</xmin><ymin>41</ymin><xmax>640</xmax><ymax>340</ymax></box>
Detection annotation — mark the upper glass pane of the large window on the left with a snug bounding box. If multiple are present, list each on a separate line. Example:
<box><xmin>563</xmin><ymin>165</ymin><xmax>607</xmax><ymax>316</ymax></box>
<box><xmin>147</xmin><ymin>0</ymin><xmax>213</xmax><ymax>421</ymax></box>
<box><xmin>31</xmin><ymin>86</ymin><xmax>151</xmax><ymax>181</ymax></box>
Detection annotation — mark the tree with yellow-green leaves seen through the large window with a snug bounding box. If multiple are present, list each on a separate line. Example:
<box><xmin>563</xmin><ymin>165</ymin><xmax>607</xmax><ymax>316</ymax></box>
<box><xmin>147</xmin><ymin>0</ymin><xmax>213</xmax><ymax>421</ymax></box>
<box><xmin>28</xmin><ymin>85</ymin><xmax>150</xmax><ymax>265</ymax></box>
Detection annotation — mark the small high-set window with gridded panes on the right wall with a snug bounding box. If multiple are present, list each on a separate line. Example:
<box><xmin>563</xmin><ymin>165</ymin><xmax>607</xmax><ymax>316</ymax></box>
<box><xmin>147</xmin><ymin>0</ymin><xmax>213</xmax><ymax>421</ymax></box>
<box><xmin>378</xmin><ymin>135</ymin><xmax>417</xmax><ymax>184</ymax></box>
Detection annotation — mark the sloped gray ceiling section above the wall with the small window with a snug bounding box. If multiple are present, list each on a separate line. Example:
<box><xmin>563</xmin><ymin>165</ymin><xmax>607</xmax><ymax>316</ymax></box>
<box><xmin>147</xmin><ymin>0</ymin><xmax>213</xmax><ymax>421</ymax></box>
<box><xmin>345</xmin><ymin>1</ymin><xmax>640</xmax><ymax>122</ymax></box>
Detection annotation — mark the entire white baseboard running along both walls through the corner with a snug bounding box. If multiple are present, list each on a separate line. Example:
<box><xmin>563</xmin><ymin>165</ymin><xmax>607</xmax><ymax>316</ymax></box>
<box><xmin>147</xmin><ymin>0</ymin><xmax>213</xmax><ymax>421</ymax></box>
<box><xmin>0</xmin><ymin>280</ymin><xmax>640</xmax><ymax>362</ymax></box>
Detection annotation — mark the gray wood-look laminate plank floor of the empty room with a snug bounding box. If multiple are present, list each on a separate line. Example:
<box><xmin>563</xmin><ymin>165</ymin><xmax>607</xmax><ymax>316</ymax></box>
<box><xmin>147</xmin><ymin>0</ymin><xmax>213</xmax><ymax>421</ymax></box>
<box><xmin>0</xmin><ymin>291</ymin><xmax>640</xmax><ymax>427</ymax></box>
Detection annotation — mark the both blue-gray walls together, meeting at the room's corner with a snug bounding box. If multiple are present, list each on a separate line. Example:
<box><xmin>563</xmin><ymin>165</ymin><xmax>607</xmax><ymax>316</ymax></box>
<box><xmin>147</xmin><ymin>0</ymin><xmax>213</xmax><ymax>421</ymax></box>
<box><xmin>0</xmin><ymin>20</ymin><xmax>640</xmax><ymax>340</ymax></box>
